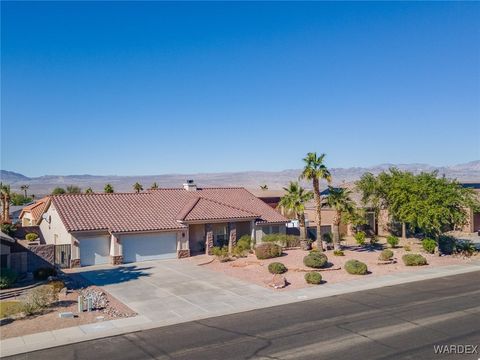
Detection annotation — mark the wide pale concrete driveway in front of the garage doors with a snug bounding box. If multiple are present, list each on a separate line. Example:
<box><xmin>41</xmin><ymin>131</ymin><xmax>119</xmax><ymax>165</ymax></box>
<box><xmin>74</xmin><ymin>259</ymin><xmax>290</xmax><ymax>322</ymax></box>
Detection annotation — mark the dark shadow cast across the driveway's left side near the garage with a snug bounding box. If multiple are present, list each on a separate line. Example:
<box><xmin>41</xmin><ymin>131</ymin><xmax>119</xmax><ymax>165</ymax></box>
<box><xmin>72</xmin><ymin>265</ymin><xmax>152</xmax><ymax>288</ymax></box>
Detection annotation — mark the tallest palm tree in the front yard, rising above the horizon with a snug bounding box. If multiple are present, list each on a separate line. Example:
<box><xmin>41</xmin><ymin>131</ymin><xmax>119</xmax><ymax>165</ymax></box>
<box><xmin>300</xmin><ymin>152</ymin><xmax>332</xmax><ymax>251</ymax></box>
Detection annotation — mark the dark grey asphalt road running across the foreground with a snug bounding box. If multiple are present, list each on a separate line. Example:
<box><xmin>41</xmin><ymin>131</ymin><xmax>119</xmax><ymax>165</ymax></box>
<box><xmin>8</xmin><ymin>272</ymin><xmax>480</xmax><ymax>360</ymax></box>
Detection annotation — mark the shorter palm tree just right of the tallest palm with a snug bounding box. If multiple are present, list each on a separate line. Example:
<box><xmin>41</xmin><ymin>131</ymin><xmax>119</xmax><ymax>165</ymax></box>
<box><xmin>323</xmin><ymin>186</ymin><xmax>355</xmax><ymax>250</ymax></box>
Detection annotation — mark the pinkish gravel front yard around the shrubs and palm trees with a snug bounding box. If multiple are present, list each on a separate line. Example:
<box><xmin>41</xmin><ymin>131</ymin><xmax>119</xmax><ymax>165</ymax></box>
<box><xmin>196</xmin><ymin>239</ymin><xmax>480</xmax><ymax>291</ymax></box>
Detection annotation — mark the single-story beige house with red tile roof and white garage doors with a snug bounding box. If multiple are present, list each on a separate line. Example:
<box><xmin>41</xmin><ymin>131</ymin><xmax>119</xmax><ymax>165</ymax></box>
<box><xmin>40</xmin><ymin>181</ymin><xmax>287</xmax><ymax>267</ymax></box>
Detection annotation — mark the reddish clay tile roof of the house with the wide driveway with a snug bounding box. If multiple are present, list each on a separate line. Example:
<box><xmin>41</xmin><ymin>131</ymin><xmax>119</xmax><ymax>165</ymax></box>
<box><xmin>52</xmin><ymin>188</ymin><xmax>287</xmax><ymax>232</ymax></box>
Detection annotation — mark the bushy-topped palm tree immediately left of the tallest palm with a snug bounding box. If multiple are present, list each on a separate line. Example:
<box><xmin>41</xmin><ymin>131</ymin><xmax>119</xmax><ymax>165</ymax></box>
<box><xmin>278</xmin><ymin>181</ymin><xmax>313</xmax><ymax>240</ymax></box>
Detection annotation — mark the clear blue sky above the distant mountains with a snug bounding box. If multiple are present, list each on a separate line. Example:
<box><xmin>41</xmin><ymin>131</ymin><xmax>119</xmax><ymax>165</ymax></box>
<box><xmin>1</xmin><ymin>2</ymin><xmax>480</xmax><ymax>176</ymax></box>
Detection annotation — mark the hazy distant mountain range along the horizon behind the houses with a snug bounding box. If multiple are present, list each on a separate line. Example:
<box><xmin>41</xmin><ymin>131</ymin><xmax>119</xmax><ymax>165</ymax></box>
<box><xmin>0</xmin><ymin>160</ymin><xmax>480</xmax><ymax>196</ymax></box>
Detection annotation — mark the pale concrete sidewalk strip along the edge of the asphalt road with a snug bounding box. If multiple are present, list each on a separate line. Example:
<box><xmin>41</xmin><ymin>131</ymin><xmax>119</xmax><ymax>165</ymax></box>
<box><xmin>0</xmin><ymin>261</ymin><xmax>480</xmax><ymax>356</ymax></box>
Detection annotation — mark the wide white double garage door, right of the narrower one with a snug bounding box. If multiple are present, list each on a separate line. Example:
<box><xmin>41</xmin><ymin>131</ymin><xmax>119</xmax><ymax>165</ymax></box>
<box><xmin>121</xmin><ymin>233</ymin><xmax>177</xmax><ymax>262</ymax></box>
